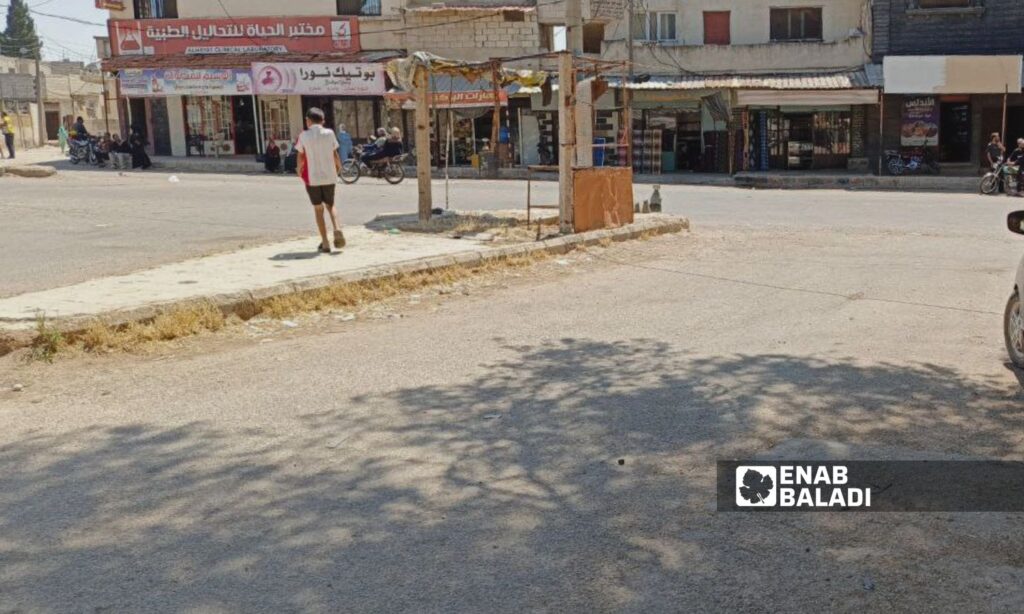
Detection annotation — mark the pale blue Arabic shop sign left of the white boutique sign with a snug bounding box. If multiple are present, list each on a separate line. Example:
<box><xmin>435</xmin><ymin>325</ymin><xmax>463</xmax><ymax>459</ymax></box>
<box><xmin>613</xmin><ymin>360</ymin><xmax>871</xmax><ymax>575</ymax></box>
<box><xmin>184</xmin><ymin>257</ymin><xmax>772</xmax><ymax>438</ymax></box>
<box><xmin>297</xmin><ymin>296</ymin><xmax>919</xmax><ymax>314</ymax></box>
<box><xmin>120</xmin><ymin>69</ymin><xmax>253</xmax><ymax>97</ymax></box>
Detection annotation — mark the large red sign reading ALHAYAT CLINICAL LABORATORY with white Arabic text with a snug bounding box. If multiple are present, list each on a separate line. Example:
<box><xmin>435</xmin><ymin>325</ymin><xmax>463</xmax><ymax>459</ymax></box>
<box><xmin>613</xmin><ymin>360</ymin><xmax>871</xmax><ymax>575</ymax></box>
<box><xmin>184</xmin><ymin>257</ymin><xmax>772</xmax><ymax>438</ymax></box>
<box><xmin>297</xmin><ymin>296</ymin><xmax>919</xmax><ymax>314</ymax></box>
<box><xmin>110</xmin><ymin>16</ymin><xmax>359</xmax><ymax>55</ymax></box>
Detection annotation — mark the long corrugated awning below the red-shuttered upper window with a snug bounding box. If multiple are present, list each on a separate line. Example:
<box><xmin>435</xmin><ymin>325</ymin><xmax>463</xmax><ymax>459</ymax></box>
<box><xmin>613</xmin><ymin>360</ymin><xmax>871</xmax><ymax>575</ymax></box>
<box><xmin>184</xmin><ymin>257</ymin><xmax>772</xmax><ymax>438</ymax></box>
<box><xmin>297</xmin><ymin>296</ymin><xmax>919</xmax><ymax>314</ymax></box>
<box><xmin>608</xmin><ymin>65</ymin><xmax>882</xmax><ymax>90</ymax></box>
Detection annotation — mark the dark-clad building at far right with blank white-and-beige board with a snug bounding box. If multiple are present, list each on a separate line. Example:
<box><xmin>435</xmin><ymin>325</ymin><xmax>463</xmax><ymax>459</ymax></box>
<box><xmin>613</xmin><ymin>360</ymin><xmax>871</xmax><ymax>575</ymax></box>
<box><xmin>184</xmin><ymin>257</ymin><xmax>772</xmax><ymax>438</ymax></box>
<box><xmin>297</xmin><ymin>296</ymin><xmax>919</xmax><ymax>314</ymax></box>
<box><xmin>872</xmin><ymin>0</ymin><xmax>1024</xmax><ymax>174</ymax></box>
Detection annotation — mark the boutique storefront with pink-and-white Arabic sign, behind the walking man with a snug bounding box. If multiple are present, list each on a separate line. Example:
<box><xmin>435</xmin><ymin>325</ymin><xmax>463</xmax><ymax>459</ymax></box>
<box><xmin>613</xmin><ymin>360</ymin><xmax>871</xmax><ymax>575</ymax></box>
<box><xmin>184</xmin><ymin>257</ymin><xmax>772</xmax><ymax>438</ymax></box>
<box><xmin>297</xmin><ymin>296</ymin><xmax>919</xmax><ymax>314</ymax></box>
<box><xmin>253</xmin><ymin>62</ymin><xmax>388</xmax><ymax>148</ymax></box>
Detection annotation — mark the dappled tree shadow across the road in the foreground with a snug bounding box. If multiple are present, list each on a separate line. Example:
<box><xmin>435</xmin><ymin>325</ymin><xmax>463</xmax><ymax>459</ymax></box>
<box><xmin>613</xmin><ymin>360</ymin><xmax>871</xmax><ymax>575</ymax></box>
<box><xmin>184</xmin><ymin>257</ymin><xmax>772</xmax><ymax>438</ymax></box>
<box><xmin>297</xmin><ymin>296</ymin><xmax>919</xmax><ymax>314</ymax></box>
<box><xmin>0</xmin><ymin>339</ymin><xmax>1024</xmax><ymax>612</ymax></box>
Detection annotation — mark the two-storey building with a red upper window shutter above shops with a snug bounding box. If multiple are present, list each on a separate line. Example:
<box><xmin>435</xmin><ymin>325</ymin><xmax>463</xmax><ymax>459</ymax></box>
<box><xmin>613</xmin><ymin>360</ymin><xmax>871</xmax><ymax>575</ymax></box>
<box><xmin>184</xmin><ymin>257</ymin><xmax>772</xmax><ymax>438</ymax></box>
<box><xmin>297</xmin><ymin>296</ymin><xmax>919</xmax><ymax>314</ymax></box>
<box><xmin>595</xmin><ymin>0</ymin><xmax>881</xmax><ymax>173</ymax></box>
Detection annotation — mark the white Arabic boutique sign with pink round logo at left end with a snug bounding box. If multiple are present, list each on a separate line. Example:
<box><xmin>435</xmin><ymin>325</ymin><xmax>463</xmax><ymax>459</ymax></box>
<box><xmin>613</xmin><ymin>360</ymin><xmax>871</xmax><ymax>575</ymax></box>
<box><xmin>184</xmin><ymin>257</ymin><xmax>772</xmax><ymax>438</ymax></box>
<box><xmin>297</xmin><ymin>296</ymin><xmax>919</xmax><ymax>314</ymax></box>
<box><xmin>253</xmin><ymin>62</ymin><xmax>385</xmax><ymax>96</ymax></box>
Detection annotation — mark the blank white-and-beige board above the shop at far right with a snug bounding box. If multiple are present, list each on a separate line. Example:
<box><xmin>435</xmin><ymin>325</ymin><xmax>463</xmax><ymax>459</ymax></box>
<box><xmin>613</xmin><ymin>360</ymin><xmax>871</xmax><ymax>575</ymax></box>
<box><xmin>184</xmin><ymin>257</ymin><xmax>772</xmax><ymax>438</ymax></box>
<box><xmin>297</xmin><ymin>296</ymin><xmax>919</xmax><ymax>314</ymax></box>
<box><xmin>883</xmin><ymin>55</ymin><xmax>1024</xmax><ymax>94</ymax></box>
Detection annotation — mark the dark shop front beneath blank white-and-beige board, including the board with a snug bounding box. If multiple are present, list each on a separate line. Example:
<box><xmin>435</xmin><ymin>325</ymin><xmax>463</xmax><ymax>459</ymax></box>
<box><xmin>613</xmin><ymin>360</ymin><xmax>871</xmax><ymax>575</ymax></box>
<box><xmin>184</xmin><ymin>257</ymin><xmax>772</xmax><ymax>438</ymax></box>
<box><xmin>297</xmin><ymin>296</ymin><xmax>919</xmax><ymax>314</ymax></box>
<box><xmin>881</xmin><ymin>55</ymin><xmax>1024</xmax><ymax>174</ymax></box>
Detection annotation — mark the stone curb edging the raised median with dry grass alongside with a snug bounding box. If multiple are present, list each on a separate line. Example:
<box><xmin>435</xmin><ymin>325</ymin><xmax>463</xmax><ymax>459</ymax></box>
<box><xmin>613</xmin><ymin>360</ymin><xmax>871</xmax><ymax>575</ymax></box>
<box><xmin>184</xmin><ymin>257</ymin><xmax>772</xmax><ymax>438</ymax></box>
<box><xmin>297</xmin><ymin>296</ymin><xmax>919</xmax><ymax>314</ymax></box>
<box><xmin>0</xmin><ymin>215</ymin><xmax>690</xmax><ymax>356</ymax></box>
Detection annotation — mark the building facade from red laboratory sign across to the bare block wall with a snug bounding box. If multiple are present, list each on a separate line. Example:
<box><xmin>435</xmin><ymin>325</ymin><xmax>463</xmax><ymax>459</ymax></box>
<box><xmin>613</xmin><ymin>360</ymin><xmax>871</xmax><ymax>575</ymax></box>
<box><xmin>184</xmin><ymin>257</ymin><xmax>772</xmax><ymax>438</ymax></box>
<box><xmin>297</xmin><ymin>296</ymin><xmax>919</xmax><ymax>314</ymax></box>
<box><xmin>104</xmin><ymin>0</ymin><xmax>552</xmax><ymax>163</ymax></box>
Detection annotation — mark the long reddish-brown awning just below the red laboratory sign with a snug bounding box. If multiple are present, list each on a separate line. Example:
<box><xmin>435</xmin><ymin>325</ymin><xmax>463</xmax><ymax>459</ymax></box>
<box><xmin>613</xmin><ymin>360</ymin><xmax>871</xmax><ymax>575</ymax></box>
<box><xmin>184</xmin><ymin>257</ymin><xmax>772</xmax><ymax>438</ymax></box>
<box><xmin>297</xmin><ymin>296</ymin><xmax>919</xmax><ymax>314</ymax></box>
<box><xmin>102</xmin><ymin>49</ymin><xmax>406</xmax><ymax>72</ymax></box>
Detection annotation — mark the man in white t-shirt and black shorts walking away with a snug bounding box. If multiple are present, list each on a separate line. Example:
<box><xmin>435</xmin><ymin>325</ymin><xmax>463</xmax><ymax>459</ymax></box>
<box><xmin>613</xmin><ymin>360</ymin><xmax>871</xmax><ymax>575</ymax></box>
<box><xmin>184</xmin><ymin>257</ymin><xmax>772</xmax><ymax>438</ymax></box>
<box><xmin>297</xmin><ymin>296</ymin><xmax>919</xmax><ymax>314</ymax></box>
<box><xmin>295</xmin><ymin>106</ymin><xmax>345</xmax><ymax>254</ymax></box>
